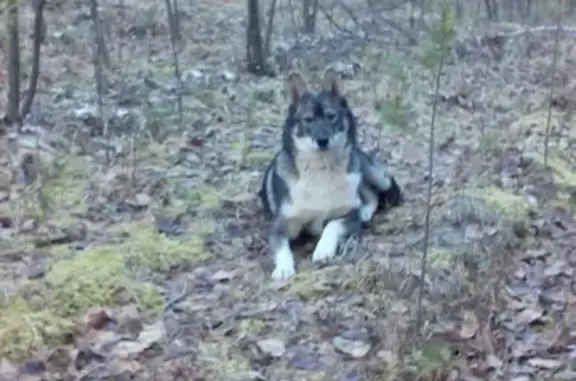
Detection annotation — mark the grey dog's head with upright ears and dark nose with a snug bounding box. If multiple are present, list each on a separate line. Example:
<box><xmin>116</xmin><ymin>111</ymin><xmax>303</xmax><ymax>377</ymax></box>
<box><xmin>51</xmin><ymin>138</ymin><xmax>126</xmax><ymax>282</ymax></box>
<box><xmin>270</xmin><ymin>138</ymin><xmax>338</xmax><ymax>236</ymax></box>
<box><xmin>284</xmin><ymin>70</ymin><xmax>354</xmax><ymax>153</ymax></box>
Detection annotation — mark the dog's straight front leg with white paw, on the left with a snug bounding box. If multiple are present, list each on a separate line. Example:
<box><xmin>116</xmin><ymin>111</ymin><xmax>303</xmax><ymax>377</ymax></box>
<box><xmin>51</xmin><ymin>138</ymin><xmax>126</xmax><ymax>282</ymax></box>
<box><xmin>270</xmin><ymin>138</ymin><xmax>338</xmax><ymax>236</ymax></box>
<box><xmin>269</xmin><ymin>218</ymin><xmax>296</xmax><ymax>280</ymax></box>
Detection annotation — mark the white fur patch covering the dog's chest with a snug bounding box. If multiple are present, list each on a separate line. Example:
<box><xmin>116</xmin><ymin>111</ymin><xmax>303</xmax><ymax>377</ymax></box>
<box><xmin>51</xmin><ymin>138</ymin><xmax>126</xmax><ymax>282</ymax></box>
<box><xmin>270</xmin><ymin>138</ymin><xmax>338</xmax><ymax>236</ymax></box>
<box><xmin>282</xmin><ymin>152</ymin><xmax>361</xmax><ymax>237</ymax></box>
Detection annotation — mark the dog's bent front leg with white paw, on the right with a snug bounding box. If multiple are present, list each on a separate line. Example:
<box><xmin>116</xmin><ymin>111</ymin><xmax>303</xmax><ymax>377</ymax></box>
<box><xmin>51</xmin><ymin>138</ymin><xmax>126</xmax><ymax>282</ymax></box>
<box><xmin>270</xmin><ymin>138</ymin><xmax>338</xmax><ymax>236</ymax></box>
<box><xmin>312</xmin><ymin>209</ymin><xmax>362</xmax><ymax>262</ymax></box>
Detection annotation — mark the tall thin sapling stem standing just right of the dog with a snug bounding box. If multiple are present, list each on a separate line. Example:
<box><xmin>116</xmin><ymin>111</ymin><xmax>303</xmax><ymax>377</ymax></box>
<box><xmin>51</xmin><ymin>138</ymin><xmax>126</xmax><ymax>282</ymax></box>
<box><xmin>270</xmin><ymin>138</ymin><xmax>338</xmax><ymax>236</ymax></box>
<box><xmin>416</xmin><ymin>29</ymin><xmax>447</xmax><ymax>333</ymax></box>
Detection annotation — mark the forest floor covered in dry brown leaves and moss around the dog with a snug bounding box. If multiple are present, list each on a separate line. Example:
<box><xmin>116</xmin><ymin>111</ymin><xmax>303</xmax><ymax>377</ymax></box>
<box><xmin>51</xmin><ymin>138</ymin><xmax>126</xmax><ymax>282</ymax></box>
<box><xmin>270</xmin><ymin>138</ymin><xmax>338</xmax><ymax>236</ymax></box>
<box><xmin>0</xmin><ymin>1</ymin><xmax>576</xmax><ymax>381</ymax></box>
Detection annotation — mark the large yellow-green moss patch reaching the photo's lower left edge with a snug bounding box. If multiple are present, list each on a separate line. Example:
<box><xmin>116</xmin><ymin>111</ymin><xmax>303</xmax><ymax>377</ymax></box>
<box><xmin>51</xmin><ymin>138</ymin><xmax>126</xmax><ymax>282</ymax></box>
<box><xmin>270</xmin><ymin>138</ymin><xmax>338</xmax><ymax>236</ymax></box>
<box><xmin>0</xmin><ymin>247</ymin><xmax>163</xmax><ymax>358</ymax></box>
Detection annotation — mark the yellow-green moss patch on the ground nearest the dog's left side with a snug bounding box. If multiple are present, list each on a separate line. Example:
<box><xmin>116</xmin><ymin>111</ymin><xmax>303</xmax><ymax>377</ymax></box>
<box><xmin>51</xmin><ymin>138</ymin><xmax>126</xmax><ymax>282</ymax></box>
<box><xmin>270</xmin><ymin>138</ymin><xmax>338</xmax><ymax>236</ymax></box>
<box><xmin>111</xmin><ymin>222</ymin><xmax>211</xmax><ymax>271</ymax></box>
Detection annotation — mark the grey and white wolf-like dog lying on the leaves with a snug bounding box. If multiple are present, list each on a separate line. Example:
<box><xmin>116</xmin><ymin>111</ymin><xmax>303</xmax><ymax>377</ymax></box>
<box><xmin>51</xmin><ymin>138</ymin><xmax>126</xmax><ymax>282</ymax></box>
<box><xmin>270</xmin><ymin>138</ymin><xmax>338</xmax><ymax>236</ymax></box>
<box><xmin>258</xmin><ymin>70</ymin><xmax>403</xmax><ymax>280</ymax></box>
